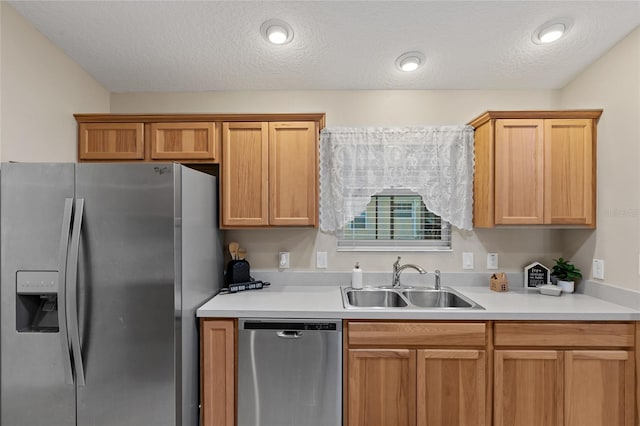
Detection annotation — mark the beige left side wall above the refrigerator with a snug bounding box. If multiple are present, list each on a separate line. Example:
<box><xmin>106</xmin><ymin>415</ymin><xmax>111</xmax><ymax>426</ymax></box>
<box><xmin>0</xmin><ymin>1</ymin><xmax>110</xmax><ymax>161</ymax></box>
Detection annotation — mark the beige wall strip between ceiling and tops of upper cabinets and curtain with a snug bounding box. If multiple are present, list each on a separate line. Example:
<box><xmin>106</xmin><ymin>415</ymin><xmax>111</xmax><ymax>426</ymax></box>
<box><xmin>111</xmin><ymin>90</ymin><xmax>558</xmax><ymax>126</ymax></box>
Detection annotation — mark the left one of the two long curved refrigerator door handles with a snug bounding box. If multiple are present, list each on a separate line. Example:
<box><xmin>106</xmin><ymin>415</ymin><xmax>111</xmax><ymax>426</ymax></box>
<box><xmin>58</xmin><ymin>198</ymin><xmax>73</xmax><ymax>385</ymax></box>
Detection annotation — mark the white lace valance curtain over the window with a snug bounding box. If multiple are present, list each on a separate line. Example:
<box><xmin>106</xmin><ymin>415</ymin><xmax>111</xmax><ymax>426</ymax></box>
<box><xmin>320</xmin><ymin>125</ymin><xmax>474</xmax><ymax>233</ymax></box>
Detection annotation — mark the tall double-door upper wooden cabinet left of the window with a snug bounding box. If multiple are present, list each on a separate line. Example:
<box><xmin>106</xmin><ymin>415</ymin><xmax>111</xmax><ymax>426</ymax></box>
<box><xmin>221</xmin><ymin>121</ymin><xmax>318</xmax><ymax>228</ymax></box>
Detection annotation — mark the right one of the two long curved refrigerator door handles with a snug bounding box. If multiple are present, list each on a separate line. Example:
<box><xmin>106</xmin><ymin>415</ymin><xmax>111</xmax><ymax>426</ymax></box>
<box><xmin>66</xmin><ymin>198</ymin><xmax>85</xmax><ymax>386</ymax></box>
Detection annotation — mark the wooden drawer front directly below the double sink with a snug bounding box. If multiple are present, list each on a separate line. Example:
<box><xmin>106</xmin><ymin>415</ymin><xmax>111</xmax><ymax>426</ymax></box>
<box><xmin>348</xmin><ymin>322</ymin><xmax>486</xmax><ymax>347</ymax></box>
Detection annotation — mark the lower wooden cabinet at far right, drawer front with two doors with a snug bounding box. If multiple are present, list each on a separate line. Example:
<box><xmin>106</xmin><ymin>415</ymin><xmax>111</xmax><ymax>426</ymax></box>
<box><xmin>493</xmin><ymin>322</ymin><xmax>636</xmax><ymax>426</ymax></box>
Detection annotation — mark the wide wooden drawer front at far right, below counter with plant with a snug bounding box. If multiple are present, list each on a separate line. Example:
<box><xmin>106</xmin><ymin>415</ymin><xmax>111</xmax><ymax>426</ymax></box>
<box><xmin>494</xmin><ymin>322</ymin><xmax>634</xmax><ymax>347</ymax></box>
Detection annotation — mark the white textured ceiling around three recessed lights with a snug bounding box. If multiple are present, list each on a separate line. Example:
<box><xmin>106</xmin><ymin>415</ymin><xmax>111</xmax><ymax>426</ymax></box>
<box><xmin>9</xmin><ymin>0</ymin><xmax>640</xmax><ymax>92</ymax></box>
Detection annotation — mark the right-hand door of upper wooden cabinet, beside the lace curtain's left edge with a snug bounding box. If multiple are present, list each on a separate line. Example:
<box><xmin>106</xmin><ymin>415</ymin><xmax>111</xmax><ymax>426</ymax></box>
<box><xmin>269</xmin><ymin>122</ymin><xmax>318</xmax><ymax>226</ymax></box>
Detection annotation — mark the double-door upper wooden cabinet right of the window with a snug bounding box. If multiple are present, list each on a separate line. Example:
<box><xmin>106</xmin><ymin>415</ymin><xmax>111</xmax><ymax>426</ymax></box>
<box><xmin>469</xmin><ymin>110</ymin><xmax>602</xmax><ymax>228</ymax></box>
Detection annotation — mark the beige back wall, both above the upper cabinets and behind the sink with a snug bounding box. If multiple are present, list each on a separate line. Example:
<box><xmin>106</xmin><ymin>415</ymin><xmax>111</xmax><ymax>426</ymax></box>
<box><xmin>111</xmin><ymin>90</ymin><xmax>560</xmax><ymax>271</ymax></box>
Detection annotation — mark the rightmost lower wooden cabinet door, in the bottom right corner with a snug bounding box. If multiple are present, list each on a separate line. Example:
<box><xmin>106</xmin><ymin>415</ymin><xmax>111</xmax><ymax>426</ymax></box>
<box><xmin>564</xmin><ymin>350</ymin><xmax>635</xmax><ymax>426</ymax></box>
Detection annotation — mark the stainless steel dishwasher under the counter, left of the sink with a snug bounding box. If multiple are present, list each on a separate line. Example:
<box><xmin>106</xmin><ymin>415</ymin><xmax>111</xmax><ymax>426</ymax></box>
<box><xmin>238</xmin><ymin>319</ymin><xmax>342</xmax><ymax>426</ymax></box>
